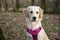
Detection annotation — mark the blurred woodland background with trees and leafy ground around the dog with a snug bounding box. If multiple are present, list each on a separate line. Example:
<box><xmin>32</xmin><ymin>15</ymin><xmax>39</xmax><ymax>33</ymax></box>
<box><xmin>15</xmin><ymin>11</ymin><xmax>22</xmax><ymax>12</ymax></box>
<box><xmin>0</xmin><ymin>0</ymin><xmax>60</xmax><ymax>40</ymax></box>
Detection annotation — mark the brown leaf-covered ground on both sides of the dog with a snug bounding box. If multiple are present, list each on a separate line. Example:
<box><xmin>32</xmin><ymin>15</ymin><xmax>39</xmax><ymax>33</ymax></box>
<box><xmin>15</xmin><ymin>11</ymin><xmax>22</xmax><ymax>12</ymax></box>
<box><xmin>0</xmin><ymin>12</ymin><xmax>60</xmax><ymax>40</ymax></box>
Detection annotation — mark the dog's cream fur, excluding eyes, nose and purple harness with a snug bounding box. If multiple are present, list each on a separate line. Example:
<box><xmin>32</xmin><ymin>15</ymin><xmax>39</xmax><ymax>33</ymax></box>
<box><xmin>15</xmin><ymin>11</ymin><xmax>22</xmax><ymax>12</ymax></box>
<box><xmin>24</xmin><ymin>6</ymin><xmax>49</xmax><ymax>40</ymax></box>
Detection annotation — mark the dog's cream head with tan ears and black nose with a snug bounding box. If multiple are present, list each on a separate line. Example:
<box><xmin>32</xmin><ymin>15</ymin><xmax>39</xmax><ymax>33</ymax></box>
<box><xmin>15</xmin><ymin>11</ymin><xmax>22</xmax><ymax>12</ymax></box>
<box><xmin>24</xmin><ymin>6</ymin><xmax>43</xmax><ymax>22</ymax></box>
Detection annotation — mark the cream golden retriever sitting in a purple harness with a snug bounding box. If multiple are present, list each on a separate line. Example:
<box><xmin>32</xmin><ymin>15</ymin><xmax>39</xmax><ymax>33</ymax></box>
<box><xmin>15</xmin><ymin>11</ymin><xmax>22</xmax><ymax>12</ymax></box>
<box><xmin>24</xmin><ymin>6</ymin><xmax>49</xmax><ymax>40</ymax></box>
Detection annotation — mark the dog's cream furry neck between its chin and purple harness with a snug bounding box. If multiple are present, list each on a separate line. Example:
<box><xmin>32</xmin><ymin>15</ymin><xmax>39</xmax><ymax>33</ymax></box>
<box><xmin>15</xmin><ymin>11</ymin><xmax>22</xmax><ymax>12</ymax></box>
<box><xmin>26</xmin><ymin>19</ymin><xmax>42</xmax><ymax>30</ymax></box>
